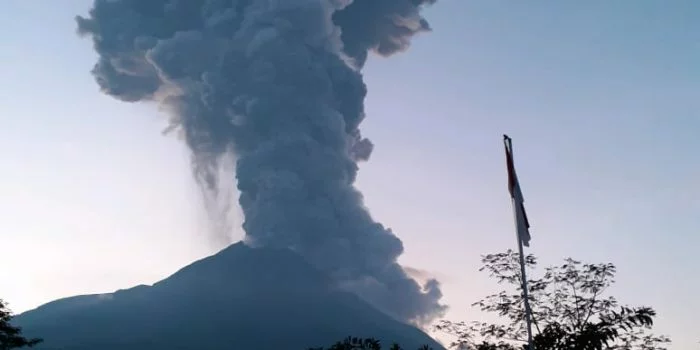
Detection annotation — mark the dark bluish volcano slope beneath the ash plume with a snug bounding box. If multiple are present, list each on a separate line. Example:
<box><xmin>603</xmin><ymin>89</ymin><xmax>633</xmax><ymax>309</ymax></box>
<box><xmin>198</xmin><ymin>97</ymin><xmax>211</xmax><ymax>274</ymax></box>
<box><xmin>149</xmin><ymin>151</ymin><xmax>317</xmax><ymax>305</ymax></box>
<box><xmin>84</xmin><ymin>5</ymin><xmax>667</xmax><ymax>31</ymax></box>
<box><xmin>15</xmin><ymin>243</ymin><xmax>442</xmax><ymax>350</ymax></box>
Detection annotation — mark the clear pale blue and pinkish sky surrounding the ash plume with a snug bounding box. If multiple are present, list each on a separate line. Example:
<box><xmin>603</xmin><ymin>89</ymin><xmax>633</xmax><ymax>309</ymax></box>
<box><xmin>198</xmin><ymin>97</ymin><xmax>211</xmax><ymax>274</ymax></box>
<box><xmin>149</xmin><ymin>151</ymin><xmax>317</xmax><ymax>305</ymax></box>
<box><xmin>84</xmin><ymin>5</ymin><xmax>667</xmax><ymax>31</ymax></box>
<box><xmin>0</xmin><ymin>0</ymin><xmax>700</xmax><ymax>350</ymax></box>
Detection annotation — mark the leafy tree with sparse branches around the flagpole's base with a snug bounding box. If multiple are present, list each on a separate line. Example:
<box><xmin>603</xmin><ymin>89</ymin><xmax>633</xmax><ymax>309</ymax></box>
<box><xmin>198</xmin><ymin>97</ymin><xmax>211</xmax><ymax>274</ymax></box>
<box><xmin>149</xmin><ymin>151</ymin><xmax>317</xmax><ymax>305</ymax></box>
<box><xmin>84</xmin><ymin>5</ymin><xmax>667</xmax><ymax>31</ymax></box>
<box><xmin>435</xmin><ymin>250</ymin><xmax>670</xmax><ymax>350</ymax></box>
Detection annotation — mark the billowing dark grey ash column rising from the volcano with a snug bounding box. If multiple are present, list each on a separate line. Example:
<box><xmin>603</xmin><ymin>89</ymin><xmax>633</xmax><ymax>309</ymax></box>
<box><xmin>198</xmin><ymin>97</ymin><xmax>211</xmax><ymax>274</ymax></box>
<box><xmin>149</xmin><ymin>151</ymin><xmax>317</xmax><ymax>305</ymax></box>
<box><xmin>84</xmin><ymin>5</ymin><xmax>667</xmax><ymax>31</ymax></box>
<box><xmin>77</xmin><ymin>0</ymin><xmax>445</xmax><ymax>324</ymax></box>
